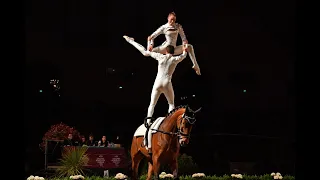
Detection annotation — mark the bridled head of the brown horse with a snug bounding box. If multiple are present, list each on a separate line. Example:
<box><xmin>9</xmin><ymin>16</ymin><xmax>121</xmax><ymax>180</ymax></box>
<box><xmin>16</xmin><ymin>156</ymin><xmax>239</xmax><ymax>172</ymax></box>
<box><xmin>177</xmin><ymin>106</ymin><xmax>201</xmax><ymax>146</ymax></box>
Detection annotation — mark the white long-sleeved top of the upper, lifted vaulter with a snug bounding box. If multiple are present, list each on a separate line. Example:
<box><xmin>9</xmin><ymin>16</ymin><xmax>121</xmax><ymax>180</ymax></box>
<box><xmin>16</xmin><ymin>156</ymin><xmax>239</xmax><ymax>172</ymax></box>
<box><xmin>149</xmin><ymin>23</ymin><xmax>187</xmax><ymax>47</ymax></box>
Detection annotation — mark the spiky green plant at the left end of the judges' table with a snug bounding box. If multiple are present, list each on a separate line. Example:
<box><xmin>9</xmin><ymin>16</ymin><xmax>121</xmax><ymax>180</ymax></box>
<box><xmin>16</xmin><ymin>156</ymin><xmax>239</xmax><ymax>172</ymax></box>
<box><xmin>56</xmin><ymin>146</ymin><xmax>89</xmax><ymax>177</ymax></box>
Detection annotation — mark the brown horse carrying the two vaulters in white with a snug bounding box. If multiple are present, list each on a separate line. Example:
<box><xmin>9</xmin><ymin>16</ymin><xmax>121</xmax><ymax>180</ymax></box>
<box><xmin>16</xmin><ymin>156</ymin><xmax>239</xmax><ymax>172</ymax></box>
<box><xmin>131</xmin><ymin>106</ymin><xmax>200</xmax><ymax>180</ymax></box>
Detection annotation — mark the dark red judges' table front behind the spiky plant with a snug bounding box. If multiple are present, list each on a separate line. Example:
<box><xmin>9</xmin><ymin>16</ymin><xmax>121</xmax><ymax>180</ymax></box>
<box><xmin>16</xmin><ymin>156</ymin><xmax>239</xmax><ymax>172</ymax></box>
<box><xmin>64</xmin><ymin>146</ymin><xmax>128</xmax><ymax>169</ymax></box>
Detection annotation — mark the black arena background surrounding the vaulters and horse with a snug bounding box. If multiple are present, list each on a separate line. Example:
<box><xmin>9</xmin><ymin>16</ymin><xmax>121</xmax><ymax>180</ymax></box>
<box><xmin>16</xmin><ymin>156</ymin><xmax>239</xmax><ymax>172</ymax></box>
<box><xmin>25</xmin><ymin>0</ymin><xmax>296</xmax><ymax>174</ymax></box>
